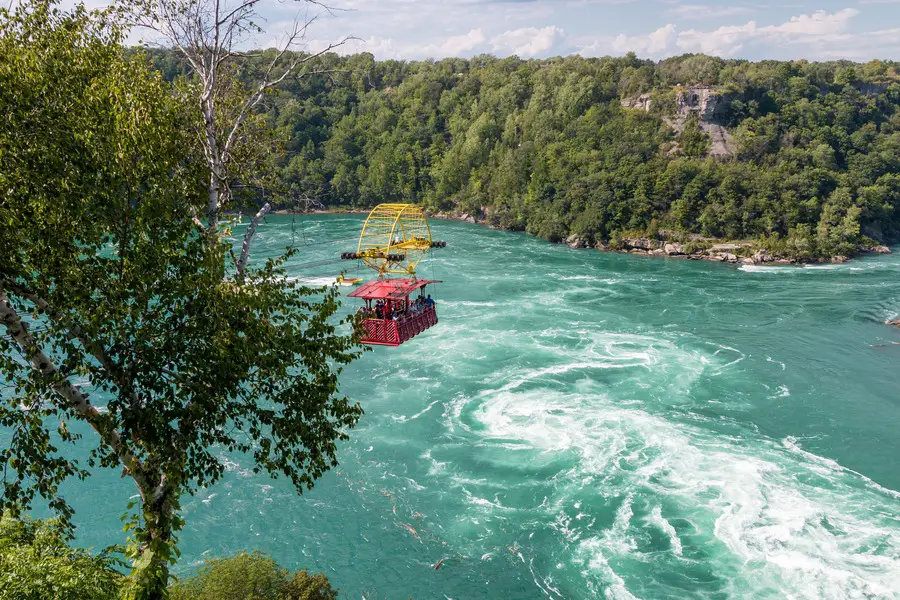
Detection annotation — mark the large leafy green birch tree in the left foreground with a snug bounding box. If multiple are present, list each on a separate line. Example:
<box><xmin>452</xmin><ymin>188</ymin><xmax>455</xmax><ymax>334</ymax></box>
<box><xmin>0</xmin><ymin>0</ymin><xmax>361</xmax><ymax>599</ymax></box>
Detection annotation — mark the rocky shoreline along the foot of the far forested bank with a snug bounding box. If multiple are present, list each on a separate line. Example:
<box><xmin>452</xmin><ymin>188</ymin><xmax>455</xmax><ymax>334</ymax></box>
<box><xmin>431</xmin><ymin>213</ymin><xmax>891</xmax><ymax>266</ymax></box>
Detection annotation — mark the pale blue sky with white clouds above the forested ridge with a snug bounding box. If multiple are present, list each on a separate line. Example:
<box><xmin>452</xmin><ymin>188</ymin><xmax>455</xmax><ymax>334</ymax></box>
<box><xmin>260</xmin><ymin>0</ymin><xmax>900</xmax><ymax>60</ymax></box>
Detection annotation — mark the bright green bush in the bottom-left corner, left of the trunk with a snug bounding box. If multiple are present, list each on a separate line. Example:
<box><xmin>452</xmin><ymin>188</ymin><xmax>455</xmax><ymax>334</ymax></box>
<box><xmin>0</xmin><ymin>512</ymin><xmax>124</xmax><ymax>600</ymax></box>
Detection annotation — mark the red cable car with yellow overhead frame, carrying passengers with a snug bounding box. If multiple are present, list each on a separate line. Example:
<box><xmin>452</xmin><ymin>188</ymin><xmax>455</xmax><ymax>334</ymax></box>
<box><xmin>341</xmin><ymin>204</ymin><xmax>447</xmax><ymax>346</ymax></box>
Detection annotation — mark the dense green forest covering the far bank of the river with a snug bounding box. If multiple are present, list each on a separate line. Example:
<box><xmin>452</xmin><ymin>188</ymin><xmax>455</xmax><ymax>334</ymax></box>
<box><xmin>152</xmin><ymin>51</ymin><xmax>900</xmax><ymax>257</ymax></box>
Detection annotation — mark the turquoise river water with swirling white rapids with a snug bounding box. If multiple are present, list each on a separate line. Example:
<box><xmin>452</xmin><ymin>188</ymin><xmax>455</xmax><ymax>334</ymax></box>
<box><xmin>45</xmin><ymin>215</ymin><xmax>900</xmax><ymax>600</ymax></box>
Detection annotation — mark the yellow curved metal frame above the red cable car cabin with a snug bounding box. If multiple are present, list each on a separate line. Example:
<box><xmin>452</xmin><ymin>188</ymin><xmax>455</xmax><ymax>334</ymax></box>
<box><xmin>356</xmin><ymin>204</ymin><xmax>431</xmax><ymax>277</ymax></box>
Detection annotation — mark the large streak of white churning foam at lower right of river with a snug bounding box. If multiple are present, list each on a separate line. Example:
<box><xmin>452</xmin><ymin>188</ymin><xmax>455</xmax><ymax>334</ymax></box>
<box><xmin>464</xmin><ymin>384</ymin><xmax>900</xmax><ymax>599</ymax></box>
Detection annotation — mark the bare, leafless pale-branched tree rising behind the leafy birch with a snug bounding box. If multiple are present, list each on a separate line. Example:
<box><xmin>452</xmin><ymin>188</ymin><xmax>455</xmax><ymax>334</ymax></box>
<box><xmin>135</xmin><ymin>0</ymin><xmax>349</xmax><ymax>280</ymax></box>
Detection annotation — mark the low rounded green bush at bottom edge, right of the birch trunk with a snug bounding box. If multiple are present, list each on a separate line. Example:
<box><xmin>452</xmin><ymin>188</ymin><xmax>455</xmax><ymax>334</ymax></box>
<box><xmin>169</xmin><ymin>552</ymin><xmax>337</xmax><ymax>600</ymax></box>
